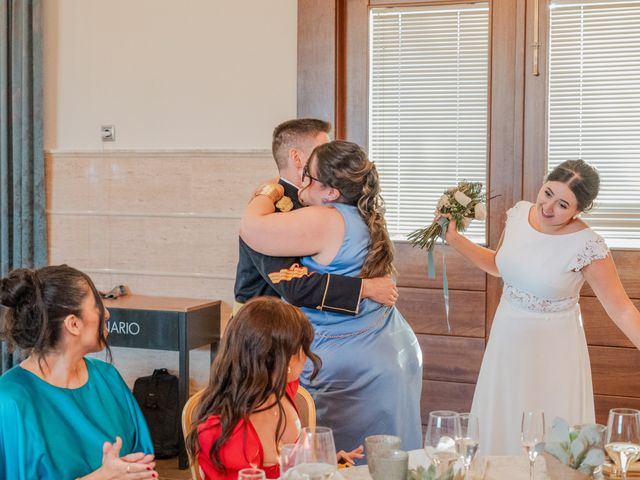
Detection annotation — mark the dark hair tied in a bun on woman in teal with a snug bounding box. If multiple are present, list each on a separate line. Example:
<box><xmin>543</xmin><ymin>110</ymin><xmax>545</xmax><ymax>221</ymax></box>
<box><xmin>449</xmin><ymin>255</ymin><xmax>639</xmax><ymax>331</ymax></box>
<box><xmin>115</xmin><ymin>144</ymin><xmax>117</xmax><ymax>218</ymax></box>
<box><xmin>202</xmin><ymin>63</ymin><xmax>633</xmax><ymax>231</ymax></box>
<box><xmin>0</xmin><ymin>265</ymin><xmax>110</xmax><ymax>360</ymax></box>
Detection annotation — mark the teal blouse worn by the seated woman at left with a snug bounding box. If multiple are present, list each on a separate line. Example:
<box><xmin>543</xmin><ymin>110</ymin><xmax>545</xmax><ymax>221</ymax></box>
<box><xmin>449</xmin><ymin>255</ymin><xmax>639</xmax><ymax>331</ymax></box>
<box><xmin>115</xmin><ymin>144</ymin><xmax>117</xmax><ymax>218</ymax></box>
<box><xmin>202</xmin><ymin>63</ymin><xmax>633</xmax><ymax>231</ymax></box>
<box><xmin>0</xmin><ymin>358</ymin><xmax>153</xmax><ymax>480</ymax></box>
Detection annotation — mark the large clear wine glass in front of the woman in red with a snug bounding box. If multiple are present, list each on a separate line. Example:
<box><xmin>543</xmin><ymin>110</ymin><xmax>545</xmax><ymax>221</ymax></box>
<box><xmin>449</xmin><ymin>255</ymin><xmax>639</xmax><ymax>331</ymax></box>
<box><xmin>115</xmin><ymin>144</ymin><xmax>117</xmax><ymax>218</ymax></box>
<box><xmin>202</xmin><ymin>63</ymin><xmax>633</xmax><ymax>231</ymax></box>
<box><xmin>294</xmin><ymin>427</ymin><xmax>338</xmax><ymax>480</ymax></box>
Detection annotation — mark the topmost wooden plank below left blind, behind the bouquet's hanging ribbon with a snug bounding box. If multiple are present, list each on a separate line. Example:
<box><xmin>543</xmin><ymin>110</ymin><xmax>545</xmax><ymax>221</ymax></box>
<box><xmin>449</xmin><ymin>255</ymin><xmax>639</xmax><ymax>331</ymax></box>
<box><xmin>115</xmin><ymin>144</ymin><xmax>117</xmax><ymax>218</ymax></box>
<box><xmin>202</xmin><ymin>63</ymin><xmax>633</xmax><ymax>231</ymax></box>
<box><xmin>395</xmin><ymin>246</ymin><xmax>486</xmax><ymax>290</ymax></box>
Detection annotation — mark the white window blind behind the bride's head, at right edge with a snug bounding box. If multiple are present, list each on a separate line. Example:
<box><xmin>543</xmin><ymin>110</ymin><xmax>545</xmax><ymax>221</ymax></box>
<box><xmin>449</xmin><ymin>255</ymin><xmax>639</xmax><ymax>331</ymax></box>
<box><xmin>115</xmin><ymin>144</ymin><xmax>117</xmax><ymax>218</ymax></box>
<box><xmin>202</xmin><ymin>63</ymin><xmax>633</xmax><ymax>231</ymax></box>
<box><xmin>548</xmin><ymin>0</ymin><xmax>640</xmax><ymax>248</ymax></box>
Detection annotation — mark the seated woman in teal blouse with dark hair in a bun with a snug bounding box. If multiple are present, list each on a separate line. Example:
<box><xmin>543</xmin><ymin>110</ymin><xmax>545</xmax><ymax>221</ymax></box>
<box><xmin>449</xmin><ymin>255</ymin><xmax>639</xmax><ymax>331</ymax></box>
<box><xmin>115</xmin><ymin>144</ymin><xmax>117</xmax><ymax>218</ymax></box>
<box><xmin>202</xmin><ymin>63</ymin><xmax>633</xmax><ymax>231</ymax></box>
<box><xmin>0</xmin><ymin>265</ymin><xmax>158</xmax><ymax>480</ymax></box>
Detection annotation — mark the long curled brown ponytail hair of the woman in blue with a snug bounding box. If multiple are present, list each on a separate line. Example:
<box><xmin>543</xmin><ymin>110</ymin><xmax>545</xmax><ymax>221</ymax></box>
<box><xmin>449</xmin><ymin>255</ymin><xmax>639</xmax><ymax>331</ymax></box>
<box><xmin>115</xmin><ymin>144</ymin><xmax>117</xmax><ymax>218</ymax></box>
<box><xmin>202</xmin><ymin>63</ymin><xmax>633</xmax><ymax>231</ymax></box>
<box><xmin>309</xmin><ymin>140</ymin><xmax>394</xmax><ymax>277</ymax></box>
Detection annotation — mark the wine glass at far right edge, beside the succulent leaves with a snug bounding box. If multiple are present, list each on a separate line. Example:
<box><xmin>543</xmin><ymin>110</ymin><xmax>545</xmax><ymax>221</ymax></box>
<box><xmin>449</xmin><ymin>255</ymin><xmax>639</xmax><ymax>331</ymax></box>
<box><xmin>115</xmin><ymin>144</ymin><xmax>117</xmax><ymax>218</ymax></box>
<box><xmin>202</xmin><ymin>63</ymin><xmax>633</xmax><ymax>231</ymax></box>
<box><xmin>604</xmin><ymin>408</ymin><xmax>640</xmax><ymax>480</ymax></box>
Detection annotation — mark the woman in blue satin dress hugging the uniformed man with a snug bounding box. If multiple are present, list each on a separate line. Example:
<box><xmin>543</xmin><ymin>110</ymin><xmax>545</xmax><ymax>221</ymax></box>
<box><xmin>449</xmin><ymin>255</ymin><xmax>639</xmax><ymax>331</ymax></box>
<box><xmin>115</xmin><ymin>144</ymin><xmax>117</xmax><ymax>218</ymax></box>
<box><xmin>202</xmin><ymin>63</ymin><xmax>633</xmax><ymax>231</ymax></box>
<box><xmin>240</xmin><ymin>141</ymin><xmax>422</xmax><ymax>451</ymax></box>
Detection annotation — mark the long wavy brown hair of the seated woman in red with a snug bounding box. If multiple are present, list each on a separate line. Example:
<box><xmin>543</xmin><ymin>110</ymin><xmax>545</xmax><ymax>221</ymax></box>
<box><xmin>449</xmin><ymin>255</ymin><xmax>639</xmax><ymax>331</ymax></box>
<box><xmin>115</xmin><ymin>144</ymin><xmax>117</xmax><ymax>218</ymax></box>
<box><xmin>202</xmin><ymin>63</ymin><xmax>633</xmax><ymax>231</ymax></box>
<box><xmin>186</xmin><ymin>297</ymin><xmax>321</xmax><ymax>472</ymax></box>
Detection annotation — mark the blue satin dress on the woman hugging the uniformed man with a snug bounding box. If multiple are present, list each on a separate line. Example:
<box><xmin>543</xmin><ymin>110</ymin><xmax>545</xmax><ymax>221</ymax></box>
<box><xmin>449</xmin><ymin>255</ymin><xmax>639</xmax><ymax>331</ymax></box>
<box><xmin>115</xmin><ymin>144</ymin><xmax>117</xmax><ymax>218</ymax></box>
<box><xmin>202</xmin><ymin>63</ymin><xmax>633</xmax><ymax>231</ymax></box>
<box><xmin>301</xmin><ymin>203</ymin><xmax>422</xmax><ymax>451</ymax></box>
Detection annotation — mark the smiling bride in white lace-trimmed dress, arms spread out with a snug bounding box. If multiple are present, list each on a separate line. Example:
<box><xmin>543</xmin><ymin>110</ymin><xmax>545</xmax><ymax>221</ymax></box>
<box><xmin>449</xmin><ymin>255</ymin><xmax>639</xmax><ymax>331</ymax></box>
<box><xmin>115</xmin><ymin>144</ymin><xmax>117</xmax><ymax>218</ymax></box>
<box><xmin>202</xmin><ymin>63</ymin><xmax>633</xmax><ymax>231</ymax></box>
<box><xmin>446</xmin><ymin>160</ymin><xmax>640</xmax><ymax>455</ymax></box>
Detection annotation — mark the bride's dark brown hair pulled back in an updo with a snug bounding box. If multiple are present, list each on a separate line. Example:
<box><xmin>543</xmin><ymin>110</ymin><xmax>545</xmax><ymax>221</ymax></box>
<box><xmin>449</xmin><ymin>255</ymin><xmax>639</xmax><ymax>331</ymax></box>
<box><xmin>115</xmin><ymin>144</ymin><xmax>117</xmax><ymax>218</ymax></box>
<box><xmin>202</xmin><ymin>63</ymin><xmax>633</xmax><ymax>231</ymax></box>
<box><xmin>547</xmin><ymin>160</ymin><xmax>600</xmax><ymax>212</ymax></box>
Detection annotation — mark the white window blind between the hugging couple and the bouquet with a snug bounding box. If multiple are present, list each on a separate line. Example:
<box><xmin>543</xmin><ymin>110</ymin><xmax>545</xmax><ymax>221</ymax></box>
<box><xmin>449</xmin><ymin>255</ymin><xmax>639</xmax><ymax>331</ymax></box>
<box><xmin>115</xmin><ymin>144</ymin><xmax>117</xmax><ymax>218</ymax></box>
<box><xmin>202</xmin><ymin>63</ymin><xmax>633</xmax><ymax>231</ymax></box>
<box><xmin>369</xmin><ymin>2</ymin><xmax>489</xmax><ymax>242</ymax></box>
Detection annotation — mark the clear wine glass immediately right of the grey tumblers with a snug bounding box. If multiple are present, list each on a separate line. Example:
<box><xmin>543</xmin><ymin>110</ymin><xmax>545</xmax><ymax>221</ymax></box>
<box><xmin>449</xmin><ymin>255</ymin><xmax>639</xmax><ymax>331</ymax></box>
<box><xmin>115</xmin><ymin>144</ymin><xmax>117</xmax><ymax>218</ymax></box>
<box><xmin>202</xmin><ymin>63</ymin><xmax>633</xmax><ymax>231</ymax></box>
<box><xmin>424</xmin><ymin>410</ymin><xmax>460</xmax><ymax>477</ymax></box>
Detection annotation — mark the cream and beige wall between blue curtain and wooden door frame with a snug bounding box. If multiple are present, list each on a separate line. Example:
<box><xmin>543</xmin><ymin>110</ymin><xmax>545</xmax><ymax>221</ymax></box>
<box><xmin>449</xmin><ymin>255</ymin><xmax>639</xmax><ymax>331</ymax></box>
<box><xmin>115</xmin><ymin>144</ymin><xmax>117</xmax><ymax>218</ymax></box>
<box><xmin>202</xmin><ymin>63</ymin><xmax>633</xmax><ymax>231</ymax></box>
<box><xmin>42</xmin><ymin>0</ymin><xmax>297</xmax><ymax>389</ymax></box>
